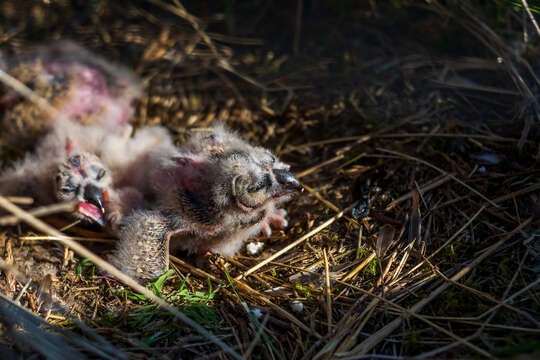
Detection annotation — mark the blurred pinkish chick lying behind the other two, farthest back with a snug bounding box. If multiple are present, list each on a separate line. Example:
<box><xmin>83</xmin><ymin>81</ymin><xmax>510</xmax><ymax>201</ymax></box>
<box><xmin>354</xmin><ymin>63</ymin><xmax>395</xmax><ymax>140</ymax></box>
<box><xmin>0</xmin><ymin>42</ymin><xmax>140</xmax><ymax>146</ymax></box>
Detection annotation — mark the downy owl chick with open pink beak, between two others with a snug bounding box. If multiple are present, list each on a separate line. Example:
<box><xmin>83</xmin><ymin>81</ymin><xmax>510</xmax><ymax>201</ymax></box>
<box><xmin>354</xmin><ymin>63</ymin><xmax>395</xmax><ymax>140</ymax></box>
<box><xmin>0</xmin><ymin>119</ymin><xmax>172</xmax><ymax>228</ymax></box>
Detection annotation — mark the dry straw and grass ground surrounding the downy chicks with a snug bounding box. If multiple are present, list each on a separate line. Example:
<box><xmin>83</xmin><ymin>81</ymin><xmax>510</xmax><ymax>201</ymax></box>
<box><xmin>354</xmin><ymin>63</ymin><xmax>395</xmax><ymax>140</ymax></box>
<box><xmin>0</xmin><ymin>0</ymin><xmax>540</xmax><ymax>359</ymax></box>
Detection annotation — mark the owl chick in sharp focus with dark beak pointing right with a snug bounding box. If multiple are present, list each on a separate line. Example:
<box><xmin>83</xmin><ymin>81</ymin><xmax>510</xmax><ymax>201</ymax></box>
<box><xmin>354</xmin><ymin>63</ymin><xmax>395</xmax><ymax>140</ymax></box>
<box><xmin>112</xmin><ymin>128</ymin><xmax>300</xmax><ymax>279</ymax></box>
